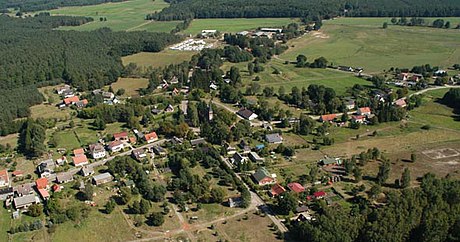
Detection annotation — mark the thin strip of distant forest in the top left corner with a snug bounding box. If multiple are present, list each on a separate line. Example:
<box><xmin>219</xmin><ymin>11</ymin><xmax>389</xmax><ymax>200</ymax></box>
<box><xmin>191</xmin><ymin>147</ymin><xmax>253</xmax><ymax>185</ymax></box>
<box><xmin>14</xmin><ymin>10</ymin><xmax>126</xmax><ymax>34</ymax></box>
<box><xmin>0</xmin><ymin>0</ymin><xmax>124</xmax><ymax>12</ymax></box>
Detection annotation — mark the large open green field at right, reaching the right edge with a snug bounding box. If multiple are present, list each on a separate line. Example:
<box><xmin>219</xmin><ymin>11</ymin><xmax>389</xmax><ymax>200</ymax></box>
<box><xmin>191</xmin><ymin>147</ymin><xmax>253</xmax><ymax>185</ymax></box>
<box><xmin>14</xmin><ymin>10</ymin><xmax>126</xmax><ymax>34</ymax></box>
<box><xmin>280</xmin><ymin>18</ymin><xmax>460</xmax><ymax>73</ymax></box>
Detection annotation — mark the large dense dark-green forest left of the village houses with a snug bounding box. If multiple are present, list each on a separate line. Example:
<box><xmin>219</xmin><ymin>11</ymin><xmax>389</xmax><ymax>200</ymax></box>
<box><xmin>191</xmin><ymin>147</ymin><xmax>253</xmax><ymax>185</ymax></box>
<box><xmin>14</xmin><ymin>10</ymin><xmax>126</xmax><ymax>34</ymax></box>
<box><xmin>0</xmin><ymin>14</ymin><xmax>180</xmax><ymax>131</ymax></box>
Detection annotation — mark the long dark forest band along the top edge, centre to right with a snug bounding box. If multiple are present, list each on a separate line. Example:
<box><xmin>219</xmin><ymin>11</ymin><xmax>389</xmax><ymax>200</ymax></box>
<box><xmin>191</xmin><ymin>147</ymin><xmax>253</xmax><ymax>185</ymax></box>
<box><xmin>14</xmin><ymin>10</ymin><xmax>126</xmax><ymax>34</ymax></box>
<box><xmin>147</xmin><ymin>0</ymin><xmax>460</xmax><ymax>20</ymax></box>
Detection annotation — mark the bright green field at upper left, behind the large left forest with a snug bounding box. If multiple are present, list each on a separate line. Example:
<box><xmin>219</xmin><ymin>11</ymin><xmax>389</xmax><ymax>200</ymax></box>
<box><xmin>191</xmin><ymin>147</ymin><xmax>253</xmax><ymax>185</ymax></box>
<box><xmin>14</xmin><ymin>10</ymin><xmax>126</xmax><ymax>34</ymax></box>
<box><xmin>50</xmin><ymin>0</ymin><xmax>177</xmax><ymax>32</ymax></box>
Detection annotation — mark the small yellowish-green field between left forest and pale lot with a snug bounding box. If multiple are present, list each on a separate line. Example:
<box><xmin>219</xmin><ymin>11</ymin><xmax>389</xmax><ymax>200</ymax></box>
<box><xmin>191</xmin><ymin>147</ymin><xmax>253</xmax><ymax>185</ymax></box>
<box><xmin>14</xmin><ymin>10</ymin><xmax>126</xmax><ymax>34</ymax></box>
<box><xmin>122</xmin><ymin>50</ymin><xmax>197</xmax><ymax>67</ymax></box>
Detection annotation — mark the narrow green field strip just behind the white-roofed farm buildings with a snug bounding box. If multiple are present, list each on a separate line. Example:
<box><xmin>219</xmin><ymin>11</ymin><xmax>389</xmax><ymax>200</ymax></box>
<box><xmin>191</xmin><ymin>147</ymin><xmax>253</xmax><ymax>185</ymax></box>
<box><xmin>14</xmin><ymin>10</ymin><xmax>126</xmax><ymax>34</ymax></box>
<box><xmin>184</xmin><ymin>18</ymin><xmax>298</xmax><ymax>34</ymax></box>
